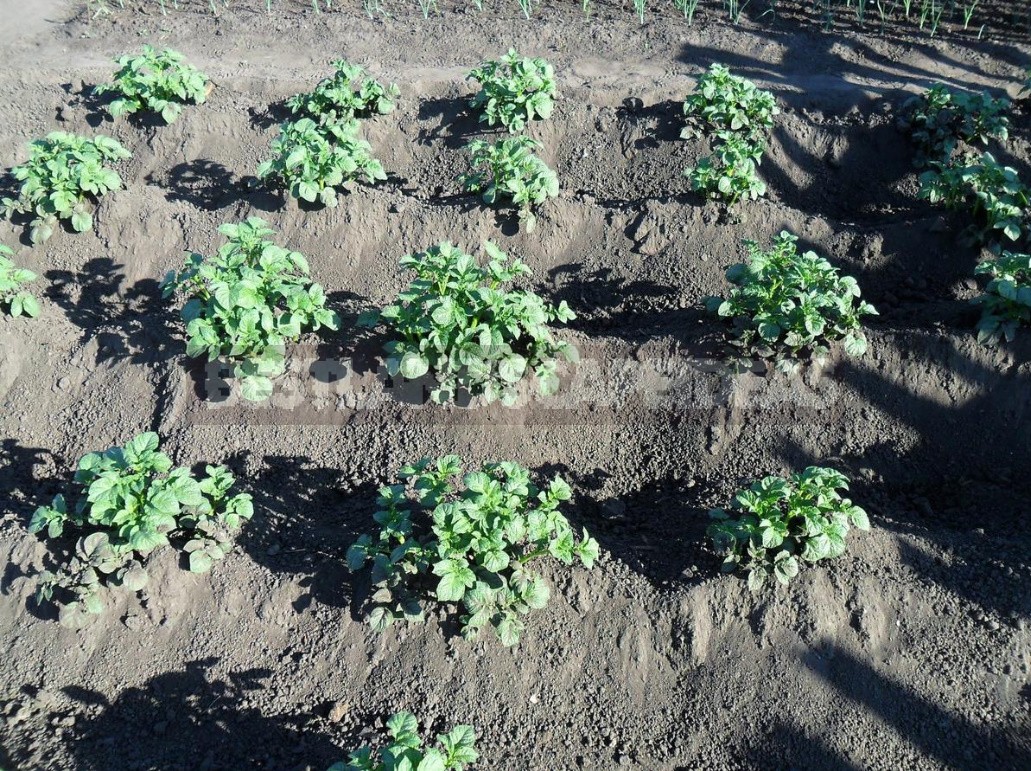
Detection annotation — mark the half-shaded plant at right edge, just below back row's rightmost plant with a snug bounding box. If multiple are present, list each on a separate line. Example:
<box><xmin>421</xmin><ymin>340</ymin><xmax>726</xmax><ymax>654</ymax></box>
<box><xmin>918</xmin><ymin>153</ymin><xmax>1031</xmax><ymax>242</ymax></box>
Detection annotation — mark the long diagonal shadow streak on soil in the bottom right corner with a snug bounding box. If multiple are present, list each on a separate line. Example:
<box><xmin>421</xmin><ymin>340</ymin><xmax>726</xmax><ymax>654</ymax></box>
<box><xmin>803</xmin><ymin>649</ymin><xmax>1031</xmax><ymax>771</ymax></box>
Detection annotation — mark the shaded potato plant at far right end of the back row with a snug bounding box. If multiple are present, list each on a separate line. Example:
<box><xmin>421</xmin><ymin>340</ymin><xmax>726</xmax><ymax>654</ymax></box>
<box><xmin>902</xmin><ymin>83</ymin><xmax>1009</xmax><ymax>168</ymax></box>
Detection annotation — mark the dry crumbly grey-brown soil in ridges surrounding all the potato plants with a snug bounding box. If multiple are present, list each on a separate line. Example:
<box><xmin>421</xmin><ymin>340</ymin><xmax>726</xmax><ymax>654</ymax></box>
<box><xmin>0</xmin><ymin>0</ymin><xmax>1031</xmax><ymax>771</ymax></box>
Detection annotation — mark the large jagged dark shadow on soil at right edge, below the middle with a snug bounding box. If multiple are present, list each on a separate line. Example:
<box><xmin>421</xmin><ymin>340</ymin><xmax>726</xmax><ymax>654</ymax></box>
<box><xmin>779</xmin><ymin>335</ymin><xmax>1031</xmax><ymax>621</ymax></box>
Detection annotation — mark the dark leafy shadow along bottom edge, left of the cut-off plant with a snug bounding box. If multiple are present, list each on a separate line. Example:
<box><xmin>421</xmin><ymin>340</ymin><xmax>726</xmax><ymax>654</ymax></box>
<box><xmin>64</xmin><ymin>658</ymin><xmax>343</xmax><ymax>771</ymax></box>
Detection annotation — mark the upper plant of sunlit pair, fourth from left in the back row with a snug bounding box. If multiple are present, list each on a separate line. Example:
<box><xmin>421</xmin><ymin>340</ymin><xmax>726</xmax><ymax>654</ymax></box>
<box><xmin>680</xmin><ymin>64</ymin><xmax>780</xmax><ymax>147</ymax></box>
